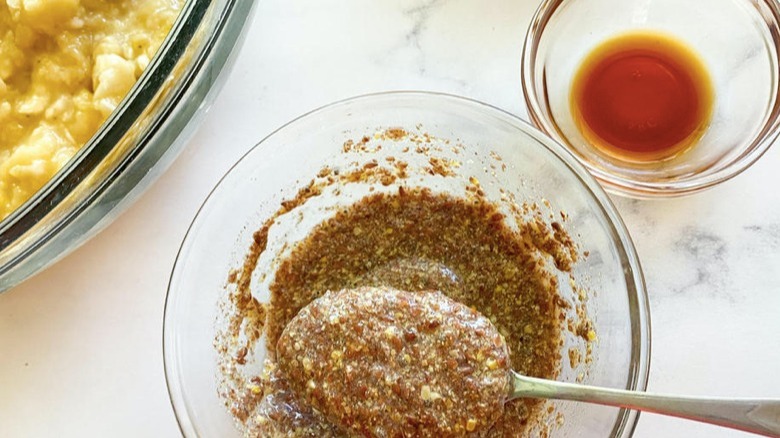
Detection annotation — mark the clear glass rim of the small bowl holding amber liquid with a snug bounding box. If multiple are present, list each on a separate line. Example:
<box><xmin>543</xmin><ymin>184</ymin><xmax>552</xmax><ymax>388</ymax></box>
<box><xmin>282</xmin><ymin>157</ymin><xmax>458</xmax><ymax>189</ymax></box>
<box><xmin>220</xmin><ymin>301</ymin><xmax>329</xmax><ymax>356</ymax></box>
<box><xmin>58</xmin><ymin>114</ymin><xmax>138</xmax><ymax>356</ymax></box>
<box><xmin>520</xmin><ymin>0</ymin><xmax>780</xmax><ymax>199</ymax></box>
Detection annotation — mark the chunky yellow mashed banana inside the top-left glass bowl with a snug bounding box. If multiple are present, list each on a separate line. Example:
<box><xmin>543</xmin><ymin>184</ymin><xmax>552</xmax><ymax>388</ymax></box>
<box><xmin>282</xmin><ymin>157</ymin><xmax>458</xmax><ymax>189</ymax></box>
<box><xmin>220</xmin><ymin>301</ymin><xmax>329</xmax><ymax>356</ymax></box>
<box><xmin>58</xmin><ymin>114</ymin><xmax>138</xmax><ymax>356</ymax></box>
<box><xmin>0</xmin><ymin>0</ymin><xmax>184</xmax><ymax>220</ymax></box>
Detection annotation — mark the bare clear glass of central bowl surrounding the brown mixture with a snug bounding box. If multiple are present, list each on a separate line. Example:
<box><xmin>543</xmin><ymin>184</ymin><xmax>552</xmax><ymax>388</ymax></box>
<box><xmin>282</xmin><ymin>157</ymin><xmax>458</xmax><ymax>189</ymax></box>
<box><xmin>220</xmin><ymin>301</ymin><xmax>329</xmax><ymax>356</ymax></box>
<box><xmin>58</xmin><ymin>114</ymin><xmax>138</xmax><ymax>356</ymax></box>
<box><xmin>163</xmin><ymin>92</ymin><xmax>650</xmax><ymax>437</ymax></box>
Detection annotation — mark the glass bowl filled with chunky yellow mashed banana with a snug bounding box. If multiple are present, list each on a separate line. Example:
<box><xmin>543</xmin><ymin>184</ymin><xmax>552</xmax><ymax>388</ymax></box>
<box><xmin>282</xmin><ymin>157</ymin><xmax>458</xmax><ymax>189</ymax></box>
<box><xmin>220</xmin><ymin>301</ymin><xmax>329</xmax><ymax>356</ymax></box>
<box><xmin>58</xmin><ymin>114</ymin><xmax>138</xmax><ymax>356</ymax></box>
<box><xmin>0</xmin><ymin>0</ymin><xmax>254</xmax><ymax>292</ymax></box>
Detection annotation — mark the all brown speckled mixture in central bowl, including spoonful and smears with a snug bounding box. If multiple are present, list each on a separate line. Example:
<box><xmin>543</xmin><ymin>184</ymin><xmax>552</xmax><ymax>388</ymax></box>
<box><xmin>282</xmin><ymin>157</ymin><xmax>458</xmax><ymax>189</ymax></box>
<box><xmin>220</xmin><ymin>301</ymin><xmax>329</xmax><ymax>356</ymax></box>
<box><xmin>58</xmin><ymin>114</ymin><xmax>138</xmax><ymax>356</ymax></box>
<box><xmin>215</xmin><ymin>130</ymin><xmax>595</xmax><ymax>437</ymax></box>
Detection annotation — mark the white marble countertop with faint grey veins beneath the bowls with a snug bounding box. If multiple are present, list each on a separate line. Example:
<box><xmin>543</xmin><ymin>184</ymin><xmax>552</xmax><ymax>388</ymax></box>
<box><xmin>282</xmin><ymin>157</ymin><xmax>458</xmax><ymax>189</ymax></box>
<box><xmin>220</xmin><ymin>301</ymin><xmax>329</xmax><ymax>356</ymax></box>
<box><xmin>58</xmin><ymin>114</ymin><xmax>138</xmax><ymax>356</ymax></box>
<box><xmin>0</xmin><ymin>0</ymin><xmax>780</xmax><ymax>437</ymax></box>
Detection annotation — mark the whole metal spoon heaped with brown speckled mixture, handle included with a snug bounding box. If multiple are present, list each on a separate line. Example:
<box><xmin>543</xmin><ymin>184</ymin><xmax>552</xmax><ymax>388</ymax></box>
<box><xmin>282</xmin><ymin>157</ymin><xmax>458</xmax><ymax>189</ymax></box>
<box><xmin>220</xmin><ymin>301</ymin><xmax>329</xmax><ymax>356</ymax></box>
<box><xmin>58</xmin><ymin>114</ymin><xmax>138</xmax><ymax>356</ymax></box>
<box><xmin>277</xmin><ymin>287</ymin><xmax>780</xmax><ymax>437</ymax></box>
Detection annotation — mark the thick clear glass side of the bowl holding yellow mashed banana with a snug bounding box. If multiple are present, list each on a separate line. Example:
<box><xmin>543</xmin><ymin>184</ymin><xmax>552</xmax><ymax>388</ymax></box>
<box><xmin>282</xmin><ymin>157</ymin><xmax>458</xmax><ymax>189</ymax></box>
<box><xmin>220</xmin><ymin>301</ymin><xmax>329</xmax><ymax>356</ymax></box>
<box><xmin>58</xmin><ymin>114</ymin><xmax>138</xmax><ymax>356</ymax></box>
<box><xmin>0</xmin><ymin>0</ymin><xmax>254</xmax><ymax>292</ymax></box>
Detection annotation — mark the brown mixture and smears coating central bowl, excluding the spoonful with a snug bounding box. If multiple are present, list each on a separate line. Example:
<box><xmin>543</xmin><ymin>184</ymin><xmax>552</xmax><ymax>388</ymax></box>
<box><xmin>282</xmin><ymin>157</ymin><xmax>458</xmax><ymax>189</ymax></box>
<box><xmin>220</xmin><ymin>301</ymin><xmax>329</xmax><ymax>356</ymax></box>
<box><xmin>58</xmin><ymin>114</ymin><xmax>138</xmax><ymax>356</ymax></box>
<box><xmin>215</xmin><ymin>129</ymin><xmax>595</xmax><ymax>437</ymax></box>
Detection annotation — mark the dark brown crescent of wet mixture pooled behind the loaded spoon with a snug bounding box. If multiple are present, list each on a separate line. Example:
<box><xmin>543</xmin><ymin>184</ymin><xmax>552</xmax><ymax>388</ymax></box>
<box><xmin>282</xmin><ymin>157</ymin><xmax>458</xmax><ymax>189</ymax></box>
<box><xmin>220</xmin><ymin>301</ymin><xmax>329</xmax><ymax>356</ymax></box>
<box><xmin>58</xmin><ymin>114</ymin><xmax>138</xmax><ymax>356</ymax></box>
<box><xmin>249</xmin><ymin>189</ymin><xmax>562</xmax><ymax>436</ymax></box>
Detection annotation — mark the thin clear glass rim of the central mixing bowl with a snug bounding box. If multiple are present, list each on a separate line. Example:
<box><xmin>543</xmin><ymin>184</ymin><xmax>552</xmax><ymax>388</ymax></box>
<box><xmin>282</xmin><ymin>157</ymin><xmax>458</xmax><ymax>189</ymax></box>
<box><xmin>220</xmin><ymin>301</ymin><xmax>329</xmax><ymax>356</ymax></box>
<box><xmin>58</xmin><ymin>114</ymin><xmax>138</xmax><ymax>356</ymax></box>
<box><xmin>162</xmin><ymin>90</ymin><xmax>651</xmax><ymax>437</ymax></box>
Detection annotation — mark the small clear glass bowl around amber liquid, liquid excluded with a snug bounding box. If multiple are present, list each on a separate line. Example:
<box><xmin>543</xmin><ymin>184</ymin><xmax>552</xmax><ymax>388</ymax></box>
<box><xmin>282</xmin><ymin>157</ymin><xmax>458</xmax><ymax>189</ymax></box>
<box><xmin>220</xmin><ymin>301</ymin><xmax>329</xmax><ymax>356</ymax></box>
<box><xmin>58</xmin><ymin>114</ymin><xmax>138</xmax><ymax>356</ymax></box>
<box><xmin>522</xmin><ymin>0</ymin><xmax>780</xmax><ymax>198</ymax></box>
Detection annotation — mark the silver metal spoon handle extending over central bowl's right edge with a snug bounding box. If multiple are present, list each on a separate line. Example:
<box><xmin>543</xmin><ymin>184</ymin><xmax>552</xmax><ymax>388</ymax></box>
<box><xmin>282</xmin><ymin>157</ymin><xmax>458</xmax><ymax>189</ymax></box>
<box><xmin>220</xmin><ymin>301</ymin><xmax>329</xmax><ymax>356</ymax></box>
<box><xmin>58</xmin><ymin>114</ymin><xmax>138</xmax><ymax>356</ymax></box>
<box><xmin>509</xmin><ymin>371</ymin><xmax>780</xmax><ymax>437</ymax></box>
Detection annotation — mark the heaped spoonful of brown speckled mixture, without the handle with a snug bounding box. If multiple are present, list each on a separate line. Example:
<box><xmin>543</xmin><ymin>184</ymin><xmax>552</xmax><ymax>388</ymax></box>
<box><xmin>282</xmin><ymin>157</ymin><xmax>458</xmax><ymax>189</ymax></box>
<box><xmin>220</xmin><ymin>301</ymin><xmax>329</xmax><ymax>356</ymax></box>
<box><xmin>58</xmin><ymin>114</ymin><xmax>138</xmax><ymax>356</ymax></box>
<box><xmin>277</xmin><ymin>287</ymin><xmax>511</xmax><ymax>437</ymax></box>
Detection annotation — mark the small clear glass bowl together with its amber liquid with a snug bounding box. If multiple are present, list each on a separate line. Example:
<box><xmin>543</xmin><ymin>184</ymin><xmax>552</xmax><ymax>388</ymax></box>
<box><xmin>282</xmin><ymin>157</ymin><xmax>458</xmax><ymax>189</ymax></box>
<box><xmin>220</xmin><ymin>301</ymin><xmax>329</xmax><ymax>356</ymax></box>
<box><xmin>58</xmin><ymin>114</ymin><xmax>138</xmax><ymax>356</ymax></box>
<box><xmin>522</xmin><ymin>0</ymin><xmax>780</xmax><ymax>198</ymax></box>
